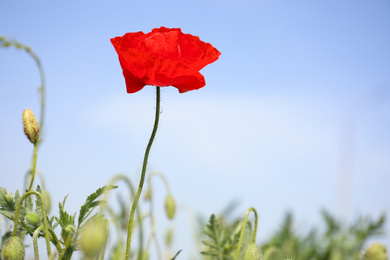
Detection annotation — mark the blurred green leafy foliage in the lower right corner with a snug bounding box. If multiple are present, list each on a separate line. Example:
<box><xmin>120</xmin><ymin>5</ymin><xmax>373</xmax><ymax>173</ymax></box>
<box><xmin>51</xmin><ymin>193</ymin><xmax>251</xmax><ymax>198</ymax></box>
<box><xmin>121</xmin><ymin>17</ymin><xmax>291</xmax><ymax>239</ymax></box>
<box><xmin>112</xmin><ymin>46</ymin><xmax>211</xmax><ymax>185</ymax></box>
<box><xmin>262</xmin><ymin>210</ymin><xmax>385</xmax><ymax>260</ymax></box>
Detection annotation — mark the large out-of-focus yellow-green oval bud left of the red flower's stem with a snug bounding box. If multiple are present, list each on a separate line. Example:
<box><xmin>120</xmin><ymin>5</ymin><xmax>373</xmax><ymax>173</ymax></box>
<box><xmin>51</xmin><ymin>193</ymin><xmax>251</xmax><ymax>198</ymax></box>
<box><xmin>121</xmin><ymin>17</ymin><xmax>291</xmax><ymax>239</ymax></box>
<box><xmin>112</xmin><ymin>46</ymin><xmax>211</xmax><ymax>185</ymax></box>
<box><xmin>79</xmin><ymin>217</ymin><xmax>108</xmax><ymax>257</ymax></box>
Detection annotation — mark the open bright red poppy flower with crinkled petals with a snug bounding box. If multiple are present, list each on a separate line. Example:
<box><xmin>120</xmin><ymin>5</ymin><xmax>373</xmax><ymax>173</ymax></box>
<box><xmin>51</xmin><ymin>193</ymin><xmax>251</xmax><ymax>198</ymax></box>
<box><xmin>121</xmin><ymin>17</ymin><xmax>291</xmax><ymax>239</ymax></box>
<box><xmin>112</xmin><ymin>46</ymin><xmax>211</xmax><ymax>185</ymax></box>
<box><xmin>111</xmin><ymin>27</ymin><xmax>221</xmax><ymax>93</ymax></box>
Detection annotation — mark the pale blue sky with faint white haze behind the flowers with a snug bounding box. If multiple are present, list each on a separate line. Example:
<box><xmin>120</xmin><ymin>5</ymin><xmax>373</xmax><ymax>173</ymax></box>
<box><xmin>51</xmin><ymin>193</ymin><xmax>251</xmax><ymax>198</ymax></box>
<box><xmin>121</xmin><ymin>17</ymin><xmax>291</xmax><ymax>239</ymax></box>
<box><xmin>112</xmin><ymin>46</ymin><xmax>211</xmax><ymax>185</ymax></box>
<box><xmin>0</xmin><ymin>0</ymin><xmax>390</xmax><ymax>255</ymax></box>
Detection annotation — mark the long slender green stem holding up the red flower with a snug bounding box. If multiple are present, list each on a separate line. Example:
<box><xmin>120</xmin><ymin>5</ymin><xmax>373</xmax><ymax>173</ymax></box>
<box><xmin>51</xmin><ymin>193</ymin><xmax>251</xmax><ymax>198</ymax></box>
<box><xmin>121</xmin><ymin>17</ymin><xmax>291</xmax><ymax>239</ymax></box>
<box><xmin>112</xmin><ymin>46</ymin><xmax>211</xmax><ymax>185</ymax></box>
<box><xmin>125</xmin><ymin>87</ymin><xmax>160</xmax><ymax>260</ymax></box>
